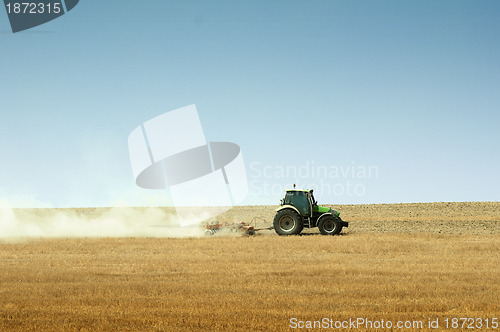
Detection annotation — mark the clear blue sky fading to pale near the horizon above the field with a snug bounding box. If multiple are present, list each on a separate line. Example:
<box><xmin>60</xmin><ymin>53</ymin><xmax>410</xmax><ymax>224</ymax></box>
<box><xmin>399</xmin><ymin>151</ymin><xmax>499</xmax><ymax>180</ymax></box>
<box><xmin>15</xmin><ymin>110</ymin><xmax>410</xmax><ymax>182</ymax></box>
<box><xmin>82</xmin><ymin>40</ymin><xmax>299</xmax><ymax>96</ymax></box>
<box><xmin>0</xmin><ymin>0</ymin><xmax>500</xmax><ymax>207</ymax></box>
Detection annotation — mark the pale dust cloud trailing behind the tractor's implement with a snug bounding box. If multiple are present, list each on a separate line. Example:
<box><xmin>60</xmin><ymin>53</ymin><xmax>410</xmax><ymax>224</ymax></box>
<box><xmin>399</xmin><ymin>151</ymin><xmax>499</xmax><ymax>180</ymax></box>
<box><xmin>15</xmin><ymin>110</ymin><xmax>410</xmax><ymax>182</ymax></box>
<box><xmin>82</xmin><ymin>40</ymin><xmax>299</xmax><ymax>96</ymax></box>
<box><xmin>0</xmin><ymin>203</ymin><xmax>204</xmax><ymax>241</ymax></box>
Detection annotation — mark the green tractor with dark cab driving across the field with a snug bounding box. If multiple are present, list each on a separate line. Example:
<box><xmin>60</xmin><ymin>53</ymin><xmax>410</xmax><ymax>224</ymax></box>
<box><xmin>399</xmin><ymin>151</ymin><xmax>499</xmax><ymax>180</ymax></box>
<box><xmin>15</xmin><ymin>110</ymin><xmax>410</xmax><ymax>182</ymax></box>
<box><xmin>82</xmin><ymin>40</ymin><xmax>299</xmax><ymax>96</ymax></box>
<box><xmin>273</xmin><ymin>186</ymin><xmax>349</xmax><ymax>235</ymax></box>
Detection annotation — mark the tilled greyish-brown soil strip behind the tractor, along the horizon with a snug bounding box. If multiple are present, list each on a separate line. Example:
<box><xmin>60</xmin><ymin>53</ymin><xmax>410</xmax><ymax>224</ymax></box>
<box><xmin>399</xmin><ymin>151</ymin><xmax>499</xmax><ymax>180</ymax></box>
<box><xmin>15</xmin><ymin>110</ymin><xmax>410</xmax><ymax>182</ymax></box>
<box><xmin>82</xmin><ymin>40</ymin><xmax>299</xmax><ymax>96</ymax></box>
<box><xmin>219</xmin><ymin>202</ymin><xmax>500</xmax><ymax>235</ymax></box>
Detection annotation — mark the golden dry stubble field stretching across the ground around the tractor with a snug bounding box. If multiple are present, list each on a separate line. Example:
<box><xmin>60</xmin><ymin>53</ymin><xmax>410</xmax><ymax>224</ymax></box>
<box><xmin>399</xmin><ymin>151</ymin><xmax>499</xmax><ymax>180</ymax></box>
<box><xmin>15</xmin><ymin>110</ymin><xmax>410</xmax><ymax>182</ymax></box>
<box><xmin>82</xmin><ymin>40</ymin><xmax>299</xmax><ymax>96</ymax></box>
<box><xmin>0</xmin><ymin>203</ymin><xmax>500</xmax><ymax>331</ymax></box>
